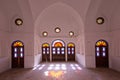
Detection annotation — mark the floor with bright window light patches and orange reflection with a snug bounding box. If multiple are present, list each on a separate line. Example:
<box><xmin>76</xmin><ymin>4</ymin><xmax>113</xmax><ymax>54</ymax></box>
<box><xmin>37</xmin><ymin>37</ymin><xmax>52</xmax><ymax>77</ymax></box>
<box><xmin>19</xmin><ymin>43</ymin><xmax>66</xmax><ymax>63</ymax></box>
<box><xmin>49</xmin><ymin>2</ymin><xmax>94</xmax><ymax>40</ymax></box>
<box><xmin>0</xmin><ymin>62</ymin><xmax>120</xmax><ymax>80</ymax></box>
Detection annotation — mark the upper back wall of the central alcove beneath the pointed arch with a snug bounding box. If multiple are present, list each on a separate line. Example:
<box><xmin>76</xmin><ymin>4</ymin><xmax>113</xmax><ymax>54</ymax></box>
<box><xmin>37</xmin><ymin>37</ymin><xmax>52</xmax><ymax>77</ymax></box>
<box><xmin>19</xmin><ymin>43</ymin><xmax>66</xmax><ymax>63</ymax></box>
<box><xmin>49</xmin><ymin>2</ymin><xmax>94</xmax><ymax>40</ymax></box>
<box><xmin>35</xmin><ymin>2</ymin><xmax>84</xmax><ymax>37</ymax></box>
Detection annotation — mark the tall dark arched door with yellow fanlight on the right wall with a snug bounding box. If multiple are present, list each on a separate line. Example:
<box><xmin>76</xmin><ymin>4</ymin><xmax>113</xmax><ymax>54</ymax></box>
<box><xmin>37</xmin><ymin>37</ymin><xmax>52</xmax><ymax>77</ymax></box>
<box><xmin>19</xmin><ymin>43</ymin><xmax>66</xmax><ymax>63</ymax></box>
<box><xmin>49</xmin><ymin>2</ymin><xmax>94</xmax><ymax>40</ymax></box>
<box><xmin>95</xmin><ymin>40</ymin><xmax>109</xmax><ymax>67</ymax></box>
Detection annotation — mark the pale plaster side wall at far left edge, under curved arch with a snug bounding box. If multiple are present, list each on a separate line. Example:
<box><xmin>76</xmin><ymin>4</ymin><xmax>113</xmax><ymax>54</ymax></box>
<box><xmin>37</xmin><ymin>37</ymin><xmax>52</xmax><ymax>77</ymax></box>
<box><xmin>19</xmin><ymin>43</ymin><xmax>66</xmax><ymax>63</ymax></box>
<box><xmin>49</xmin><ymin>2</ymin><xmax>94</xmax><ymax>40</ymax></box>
<box><xmin>0</xmin><ymin>8</ymin><xmax>10</xmax><ymax>73</ymax></box>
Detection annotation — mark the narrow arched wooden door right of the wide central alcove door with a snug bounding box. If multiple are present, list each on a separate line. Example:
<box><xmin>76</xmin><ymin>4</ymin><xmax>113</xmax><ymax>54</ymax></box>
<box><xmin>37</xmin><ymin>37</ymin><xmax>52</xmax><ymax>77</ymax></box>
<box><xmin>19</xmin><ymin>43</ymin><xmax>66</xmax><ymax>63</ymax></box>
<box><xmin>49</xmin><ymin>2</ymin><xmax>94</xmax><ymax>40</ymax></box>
<box><xmin>67</xmin><ymin>43</ymin><xmax>75</xmax><ymax>61</ymax></box>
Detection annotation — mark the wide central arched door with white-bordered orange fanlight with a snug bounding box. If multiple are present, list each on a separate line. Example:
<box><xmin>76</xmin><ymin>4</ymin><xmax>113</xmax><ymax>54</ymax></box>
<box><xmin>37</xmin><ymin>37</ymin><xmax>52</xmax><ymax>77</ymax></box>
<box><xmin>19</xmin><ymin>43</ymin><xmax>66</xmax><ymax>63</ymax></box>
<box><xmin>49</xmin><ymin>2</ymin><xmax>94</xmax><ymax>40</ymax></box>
<box><xmin>52</xmin><ymin>40</ymin><xmax>65</xmax><ymax>61</ymax></box>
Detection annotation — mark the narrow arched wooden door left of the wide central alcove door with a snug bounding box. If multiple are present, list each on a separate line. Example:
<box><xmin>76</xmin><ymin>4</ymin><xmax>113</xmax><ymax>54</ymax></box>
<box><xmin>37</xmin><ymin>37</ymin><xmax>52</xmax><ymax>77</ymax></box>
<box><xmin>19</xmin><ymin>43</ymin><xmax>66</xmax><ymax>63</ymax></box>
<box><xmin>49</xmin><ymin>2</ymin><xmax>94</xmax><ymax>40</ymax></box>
<box><xmin>42</xmin><ymin>43</ymin><xmax>50</xmax><ymax>61</ymax></box>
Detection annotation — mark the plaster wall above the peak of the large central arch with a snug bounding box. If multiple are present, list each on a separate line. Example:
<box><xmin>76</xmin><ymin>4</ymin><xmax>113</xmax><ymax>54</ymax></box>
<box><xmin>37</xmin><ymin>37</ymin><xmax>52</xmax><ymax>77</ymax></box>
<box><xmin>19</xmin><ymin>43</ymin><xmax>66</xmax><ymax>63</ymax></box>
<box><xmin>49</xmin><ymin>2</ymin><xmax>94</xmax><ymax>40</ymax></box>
<box><xmin>29</xmin><ymin>0</ymin><xmax>92</xmax><ymax>21</ymax></box>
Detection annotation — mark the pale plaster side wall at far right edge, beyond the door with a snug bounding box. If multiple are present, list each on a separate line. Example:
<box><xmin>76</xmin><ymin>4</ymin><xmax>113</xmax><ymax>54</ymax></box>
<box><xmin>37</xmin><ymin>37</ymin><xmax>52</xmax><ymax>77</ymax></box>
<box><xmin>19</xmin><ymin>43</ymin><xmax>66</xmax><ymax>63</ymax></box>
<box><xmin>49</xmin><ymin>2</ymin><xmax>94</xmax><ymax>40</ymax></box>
<box><xmin>110</xmin><ymin>3</ymin><xmax>120</xmax><ymax>71</ymax></box>
